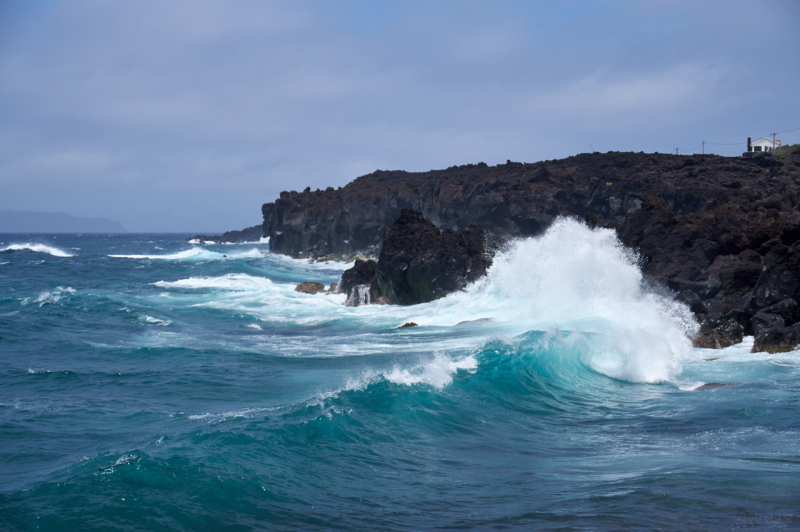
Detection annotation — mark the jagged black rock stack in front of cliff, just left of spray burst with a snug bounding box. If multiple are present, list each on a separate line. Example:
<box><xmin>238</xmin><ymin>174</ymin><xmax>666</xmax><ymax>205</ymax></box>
<box><xmin>372</xmin><ymin>208</ymin><xmax>492</xmax><ymax>305</ymax></box>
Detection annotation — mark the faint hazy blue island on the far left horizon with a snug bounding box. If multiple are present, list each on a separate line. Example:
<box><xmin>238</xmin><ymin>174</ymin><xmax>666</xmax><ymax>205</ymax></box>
<box><xmin>0</xmin><ymin>210</ymin><xmax>128</xmax><ymax>233</ymax></box>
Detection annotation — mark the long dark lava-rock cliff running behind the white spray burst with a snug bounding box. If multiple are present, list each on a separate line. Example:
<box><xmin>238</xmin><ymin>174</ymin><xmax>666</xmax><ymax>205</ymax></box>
<box><xmin>262</xmin><ymin>147</ymin><xmax>800</xmax><ymax>349</ymax></box>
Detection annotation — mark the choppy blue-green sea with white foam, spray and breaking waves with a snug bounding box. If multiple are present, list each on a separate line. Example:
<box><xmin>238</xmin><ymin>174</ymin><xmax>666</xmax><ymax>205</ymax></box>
<box><xmin>0</xmin><ymin>221</ymin><xmax>800</xmax><ymax>531</ymax></box>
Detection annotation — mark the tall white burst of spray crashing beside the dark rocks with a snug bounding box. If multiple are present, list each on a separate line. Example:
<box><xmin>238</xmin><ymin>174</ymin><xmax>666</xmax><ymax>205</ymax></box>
<box><xmin>414</xmin><ymin>218</ymin><xmax>697</xmax><ymax>382</ymax></box>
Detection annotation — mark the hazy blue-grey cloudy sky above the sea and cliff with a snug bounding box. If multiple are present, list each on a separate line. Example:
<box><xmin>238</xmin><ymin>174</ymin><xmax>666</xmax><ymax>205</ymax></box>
<box><xmin>0</xmin><ymin>0</ymin><xmax>800</xmax><ymax>233</ymax></box>
